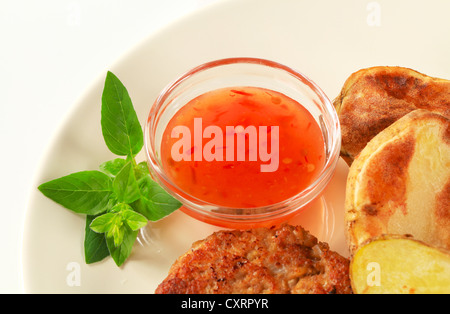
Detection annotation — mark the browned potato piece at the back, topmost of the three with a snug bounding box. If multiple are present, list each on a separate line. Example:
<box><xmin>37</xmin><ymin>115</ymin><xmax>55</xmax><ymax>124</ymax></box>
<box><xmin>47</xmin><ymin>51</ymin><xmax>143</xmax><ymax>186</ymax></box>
<box><xmin>334</xmin><ymin>66</ymin><xmax>450</xmax><ymax>165</ymax></box>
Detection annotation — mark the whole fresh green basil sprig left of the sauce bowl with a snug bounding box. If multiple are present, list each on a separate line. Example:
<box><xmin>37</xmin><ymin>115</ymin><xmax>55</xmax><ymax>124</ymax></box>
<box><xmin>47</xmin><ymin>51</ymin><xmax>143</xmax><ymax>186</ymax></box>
<box><xmin>38</xmin><ymin>72</ymin><xmax>181</xmax><ymax>266</ymax></box>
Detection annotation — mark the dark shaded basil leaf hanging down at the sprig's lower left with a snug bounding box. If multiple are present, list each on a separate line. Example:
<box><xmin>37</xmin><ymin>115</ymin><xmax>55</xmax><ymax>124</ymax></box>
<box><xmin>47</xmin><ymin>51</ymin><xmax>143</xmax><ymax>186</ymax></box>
<box><xmin>84</xmin><ymin>215</ymin><xmax>109</xmax><ymax>264</ymax></box>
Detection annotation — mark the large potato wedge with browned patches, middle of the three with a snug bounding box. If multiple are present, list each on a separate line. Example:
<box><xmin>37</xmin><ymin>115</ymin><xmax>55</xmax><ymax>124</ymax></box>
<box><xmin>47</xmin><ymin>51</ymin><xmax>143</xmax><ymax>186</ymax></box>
<box><xmin>345</xmin><ymin>110</ymin><xmax>450</xmax><ymax>253</ymax></box>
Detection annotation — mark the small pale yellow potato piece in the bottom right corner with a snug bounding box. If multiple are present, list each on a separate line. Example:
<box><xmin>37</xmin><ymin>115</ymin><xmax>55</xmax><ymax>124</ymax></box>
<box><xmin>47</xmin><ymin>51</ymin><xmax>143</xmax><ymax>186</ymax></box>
<box><xmin>350</xmin><ymin>236</ymin><xmax>450</xmax><ymax>294</ymax></box>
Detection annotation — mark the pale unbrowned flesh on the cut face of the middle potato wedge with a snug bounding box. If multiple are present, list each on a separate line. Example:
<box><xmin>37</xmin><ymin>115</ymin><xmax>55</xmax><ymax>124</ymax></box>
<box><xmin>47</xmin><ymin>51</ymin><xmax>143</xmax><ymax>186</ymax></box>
<box><xmin>387</xmin><ymin>123</ymin><xmax>450</xmax><ymax>247</ymax></box>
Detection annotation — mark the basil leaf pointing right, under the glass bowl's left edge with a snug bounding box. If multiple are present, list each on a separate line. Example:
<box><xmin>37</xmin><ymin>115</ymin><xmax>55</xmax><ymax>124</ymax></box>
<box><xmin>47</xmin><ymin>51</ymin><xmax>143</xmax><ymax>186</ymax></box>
<box><xmin>130</xmin><ymin>174</ymin><xmax>181</xmax><ymax>221</ymax></box>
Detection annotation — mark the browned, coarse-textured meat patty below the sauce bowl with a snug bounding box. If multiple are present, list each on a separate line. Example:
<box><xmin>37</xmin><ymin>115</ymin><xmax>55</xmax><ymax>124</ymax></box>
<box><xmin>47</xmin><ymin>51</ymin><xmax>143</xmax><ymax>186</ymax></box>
<box><xmin>155</xmin><ymin>225</ymin><xmax>352</xmax><ymax>294</ymax></box>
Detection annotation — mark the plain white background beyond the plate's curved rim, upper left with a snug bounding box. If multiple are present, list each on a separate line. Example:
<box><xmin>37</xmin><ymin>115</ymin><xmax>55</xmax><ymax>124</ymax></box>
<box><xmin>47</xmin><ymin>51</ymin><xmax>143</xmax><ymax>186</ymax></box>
<box><xmin>0</xmin><ymin>0</ymin><xmax>218</xmax><ymax>293</ymax></box>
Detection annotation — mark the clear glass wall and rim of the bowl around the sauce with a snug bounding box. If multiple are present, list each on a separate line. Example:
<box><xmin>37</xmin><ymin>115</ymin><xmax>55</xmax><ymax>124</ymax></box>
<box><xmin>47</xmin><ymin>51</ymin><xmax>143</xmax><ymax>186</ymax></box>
<box><xmin>144</xmin><ymin>58</ymin><xmax>341</xmax><ymax>228</ymax></box>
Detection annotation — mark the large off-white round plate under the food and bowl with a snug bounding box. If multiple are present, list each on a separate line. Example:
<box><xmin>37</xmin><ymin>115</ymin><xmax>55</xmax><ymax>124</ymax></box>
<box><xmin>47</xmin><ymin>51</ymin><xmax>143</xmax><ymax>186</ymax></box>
<box><xmin>22</xmin><ymin>0</ymin><xmax>450</xmax><ymax>293</ymax></box>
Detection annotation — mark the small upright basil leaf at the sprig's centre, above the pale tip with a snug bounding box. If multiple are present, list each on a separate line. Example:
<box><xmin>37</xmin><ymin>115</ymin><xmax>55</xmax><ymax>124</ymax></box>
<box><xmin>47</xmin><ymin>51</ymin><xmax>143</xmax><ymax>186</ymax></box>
<box><xmin>113</xmin><ymin>161</ymin><xmax>140</xmax><ymax>203</ymax></box>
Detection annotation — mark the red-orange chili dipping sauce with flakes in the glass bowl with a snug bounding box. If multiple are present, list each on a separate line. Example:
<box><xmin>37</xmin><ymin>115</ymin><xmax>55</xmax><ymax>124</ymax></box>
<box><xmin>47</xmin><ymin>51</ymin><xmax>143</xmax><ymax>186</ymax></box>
<box><xmin>161</xmin><ymin>87</ymin><xmax>325</xmax><ymax>208</ymax></box>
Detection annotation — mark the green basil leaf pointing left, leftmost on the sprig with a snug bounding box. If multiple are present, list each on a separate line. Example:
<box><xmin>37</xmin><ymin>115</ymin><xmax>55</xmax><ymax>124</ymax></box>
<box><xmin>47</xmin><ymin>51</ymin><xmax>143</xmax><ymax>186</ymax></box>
<box><xmin>38</xmin><ymin>171</ymin><xmax>113</xmax><ymax>215</ymax></box>
